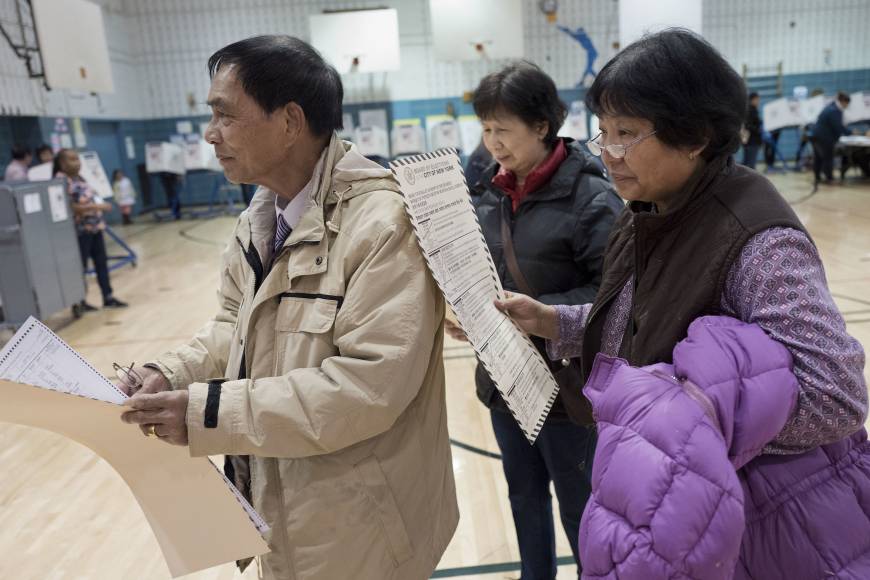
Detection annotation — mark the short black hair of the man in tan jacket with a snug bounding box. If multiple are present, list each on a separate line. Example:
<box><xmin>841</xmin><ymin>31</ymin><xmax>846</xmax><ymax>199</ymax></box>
<box><xmin>208</xmin><ymin>35</ymin><xmax>344</xmax><ymax>137</ymax></box>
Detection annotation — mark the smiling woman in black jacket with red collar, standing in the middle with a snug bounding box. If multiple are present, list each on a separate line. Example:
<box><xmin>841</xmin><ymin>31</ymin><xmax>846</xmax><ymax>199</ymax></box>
<box><xmin>447</xmin><ymin>62</ymin><xmax>623</xmax><ymax>580</ymax></box>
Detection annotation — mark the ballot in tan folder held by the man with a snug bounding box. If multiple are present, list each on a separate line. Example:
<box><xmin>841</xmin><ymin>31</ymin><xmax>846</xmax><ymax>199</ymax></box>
<box><xmin>0</xmin><ymin>317</ymin><xmax>269</xmax><ymax>577</ymax></box>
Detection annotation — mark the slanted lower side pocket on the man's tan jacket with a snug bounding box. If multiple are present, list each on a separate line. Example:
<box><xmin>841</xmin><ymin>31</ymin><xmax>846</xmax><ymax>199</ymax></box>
<box><xmin>354</xmin><ymin>455</ymin><xmax>414</xmax><ymax>567</ymax></box>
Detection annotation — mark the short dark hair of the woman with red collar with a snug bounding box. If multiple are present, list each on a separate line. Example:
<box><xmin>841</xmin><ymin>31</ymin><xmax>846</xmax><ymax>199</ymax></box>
<box><xmin>473</xmin><ymin>61</ymin><xmax>568</xmax><ymax>146</ymax></box>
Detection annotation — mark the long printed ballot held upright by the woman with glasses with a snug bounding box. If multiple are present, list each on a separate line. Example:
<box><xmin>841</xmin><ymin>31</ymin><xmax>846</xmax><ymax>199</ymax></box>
<box><xmin>390</xmin><ymin>149</ymin><xmax>558</xmax><ymax>443</ymax></box>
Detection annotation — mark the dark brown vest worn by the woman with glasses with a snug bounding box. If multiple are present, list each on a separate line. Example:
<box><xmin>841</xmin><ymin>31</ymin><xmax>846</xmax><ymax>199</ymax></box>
<box><xmin>583</xmin><ymin>157</ymin><xmax>806</xmax><ymax>381</ymax></box>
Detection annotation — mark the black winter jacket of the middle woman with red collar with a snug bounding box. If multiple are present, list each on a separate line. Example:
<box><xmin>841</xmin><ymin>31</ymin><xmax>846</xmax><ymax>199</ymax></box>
<box><xmin>472</xmin><ymin>139</ymin><xmax>623</xmax><ymax>418</ymax></box>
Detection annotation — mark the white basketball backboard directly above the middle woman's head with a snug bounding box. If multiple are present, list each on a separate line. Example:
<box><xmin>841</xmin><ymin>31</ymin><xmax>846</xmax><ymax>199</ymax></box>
<box><xmin>429</xmin><ymin>0</ymin><xmax>524</xmax><ymax>61</ymax></box>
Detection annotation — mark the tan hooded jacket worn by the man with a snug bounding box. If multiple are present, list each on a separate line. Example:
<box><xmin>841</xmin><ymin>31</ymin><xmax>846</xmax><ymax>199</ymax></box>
<box><xmin>151</xmin><ymin>137</ymin><xmax>459</xmax><ymax>580</ymax></box>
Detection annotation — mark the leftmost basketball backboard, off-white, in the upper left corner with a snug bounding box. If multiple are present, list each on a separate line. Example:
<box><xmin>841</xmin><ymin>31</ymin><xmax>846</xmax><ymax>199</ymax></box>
<box><xmin>32</xmin><ymin>0</ymin><xmax>114</xmax><ymax>93</ymax></box>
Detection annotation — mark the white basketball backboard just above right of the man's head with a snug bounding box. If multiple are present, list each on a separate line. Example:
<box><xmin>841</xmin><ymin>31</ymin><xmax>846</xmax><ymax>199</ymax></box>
<box><xmin>309</xmin><ymin>8</ymin><xmax>400</xmax><ymax>74</ymax></box>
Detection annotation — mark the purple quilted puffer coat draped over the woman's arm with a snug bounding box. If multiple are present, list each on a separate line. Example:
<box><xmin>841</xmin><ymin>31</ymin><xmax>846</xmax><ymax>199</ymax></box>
<box><xmin>579</xmin><ymin>317</ymin><xmax>870</xmax><ymax>580</ymax></box>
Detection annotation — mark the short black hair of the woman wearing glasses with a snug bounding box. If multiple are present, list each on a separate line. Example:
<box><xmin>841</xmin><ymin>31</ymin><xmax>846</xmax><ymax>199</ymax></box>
<box><xmin>586</xmin><ymin>28</ymin><xmax>747</xmax><ymax>160</ymax></box>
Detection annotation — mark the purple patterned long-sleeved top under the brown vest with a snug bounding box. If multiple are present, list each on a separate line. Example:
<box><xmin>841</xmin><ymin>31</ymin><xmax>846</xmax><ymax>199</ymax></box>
<box><xmin>547</xmin><ymin>228</ymin><xmax>867</xmax><ymax>454</ymax></box>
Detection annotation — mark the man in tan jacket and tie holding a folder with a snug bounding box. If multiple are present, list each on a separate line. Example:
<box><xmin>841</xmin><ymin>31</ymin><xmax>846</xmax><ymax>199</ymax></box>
<box><xmin>118</xmin><ymin>36</ymin><xmax>459</xmax><ymax>580</ymax></box>
